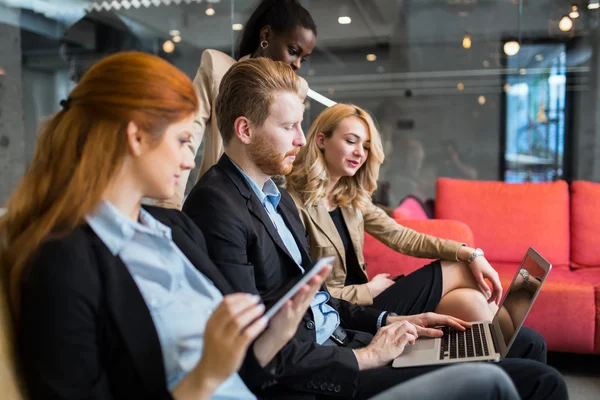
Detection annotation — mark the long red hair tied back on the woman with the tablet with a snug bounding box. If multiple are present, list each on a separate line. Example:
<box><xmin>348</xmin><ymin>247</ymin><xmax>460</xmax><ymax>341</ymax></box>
<box><xmin>0</xmin><ymin>52</ymin><xmax>199</xmax><ymax>317</ymax></box>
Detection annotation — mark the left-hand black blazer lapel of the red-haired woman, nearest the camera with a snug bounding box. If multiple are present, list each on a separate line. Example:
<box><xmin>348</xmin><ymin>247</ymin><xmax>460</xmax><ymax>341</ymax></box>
<box><xmin>90</xmin><ymin>229</ymin><xmax>167</xmax><ymax>394</ymax></box>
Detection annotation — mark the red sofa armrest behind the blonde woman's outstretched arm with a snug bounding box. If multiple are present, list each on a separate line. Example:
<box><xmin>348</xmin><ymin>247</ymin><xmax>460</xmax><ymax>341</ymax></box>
<box><xmin>363</xmin><ymin>219</ymin><xmax>474</xmax><ymax>277</ymax></box>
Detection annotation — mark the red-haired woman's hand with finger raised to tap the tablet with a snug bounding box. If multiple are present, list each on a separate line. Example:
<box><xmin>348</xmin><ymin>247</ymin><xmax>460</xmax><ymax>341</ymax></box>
<box><xmin>173</xmin><ymin>293</ymin><xmax>266</xmax><ymax>399</ymax></box>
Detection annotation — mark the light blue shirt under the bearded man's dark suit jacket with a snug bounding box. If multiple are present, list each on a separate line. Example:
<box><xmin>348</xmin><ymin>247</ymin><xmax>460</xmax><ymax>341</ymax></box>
<box><xmin>231</xmin><ymin>161</ymin><xmax>340</xmax><ymax>344</ymax></box>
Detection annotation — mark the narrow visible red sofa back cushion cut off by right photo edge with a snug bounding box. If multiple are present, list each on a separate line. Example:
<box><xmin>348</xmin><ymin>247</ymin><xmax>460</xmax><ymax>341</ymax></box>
<box><xmin>571</xmin><ymin>181</ymin><xmax>600</xmax><ymax>268</ymax></box>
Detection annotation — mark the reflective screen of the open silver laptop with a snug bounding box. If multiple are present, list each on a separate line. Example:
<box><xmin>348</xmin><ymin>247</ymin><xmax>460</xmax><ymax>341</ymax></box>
<box><xmin>494</xmin><ymin>249</ymin><xmax>550</xmax><ymax>347</ymax></box>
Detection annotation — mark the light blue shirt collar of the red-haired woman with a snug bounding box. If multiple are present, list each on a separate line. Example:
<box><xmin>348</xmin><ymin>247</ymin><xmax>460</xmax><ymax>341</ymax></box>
<box><xmin>86</xmin><ymin>201</ymin><xmax>171</xmax><ymax>256</ymax></box>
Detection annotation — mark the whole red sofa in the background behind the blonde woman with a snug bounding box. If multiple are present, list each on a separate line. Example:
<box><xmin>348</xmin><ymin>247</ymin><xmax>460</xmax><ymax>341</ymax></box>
<box><xmin>364</xmin><ymin>179</ymin><xmax>600</xmax><ymax>354</ymax></box>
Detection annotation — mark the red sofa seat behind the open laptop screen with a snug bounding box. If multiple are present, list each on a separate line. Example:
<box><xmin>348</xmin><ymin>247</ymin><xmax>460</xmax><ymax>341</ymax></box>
<box><xmin>493</xmin><ymin>263</ymin><xmax>600</xmax><ymax>353</ymax></box>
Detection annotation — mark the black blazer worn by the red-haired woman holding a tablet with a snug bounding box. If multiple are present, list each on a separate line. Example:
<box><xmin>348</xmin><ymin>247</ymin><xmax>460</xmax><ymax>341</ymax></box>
<box><xmin>19</xmin><ymin>207</ymin><xmax>273</xmax><ymax>399</ymax></box>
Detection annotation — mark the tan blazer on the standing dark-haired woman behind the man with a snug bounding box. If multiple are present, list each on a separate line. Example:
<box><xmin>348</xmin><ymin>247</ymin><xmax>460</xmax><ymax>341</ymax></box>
<box><xmin>156</xmin><ymin>49</ymin><xmax>308</xmax><ymax>209</ymax></box>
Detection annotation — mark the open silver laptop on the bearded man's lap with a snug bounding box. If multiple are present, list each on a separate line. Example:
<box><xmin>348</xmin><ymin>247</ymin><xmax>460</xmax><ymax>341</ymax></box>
<box><xmin>392</xmin><ymin>248</ymin><xmax>552</xmax><ymax>368</ymax></box>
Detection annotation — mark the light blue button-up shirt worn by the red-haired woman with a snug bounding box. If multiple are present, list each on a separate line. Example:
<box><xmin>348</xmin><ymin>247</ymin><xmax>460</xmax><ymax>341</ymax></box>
<box><xmin>86</xmin><ymin>202</ymin><xmax>256</xmax><ymax>400</ymax></box>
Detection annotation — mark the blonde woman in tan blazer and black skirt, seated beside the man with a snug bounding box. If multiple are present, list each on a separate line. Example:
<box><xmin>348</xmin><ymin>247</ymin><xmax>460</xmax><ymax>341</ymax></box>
<box><xmin>287</xmin><ymin>104</ymin><xmax>502</xmax><ymax>321</ymax></box>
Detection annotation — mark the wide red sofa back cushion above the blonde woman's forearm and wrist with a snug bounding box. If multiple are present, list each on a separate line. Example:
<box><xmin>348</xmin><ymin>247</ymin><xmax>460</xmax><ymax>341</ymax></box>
<box><xmin>435</xmin><ymin>178</ymin><xmax>570</xmax><ymax>265</ymax></box>
